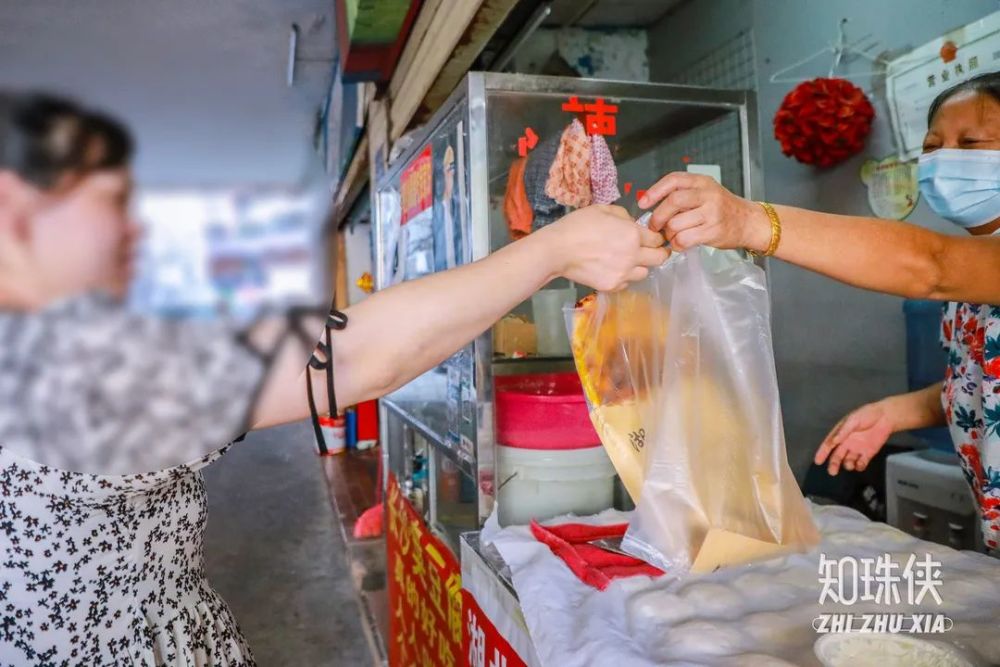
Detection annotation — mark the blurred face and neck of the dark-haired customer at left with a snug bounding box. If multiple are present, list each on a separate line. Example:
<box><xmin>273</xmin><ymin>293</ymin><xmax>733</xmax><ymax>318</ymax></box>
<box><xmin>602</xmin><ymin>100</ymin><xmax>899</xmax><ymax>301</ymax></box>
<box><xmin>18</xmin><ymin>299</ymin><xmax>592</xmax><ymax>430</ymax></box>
<box><xmin>0</xmin><ymin>169</ymin><xmax>135</xmax><ymax>309</ymax></box>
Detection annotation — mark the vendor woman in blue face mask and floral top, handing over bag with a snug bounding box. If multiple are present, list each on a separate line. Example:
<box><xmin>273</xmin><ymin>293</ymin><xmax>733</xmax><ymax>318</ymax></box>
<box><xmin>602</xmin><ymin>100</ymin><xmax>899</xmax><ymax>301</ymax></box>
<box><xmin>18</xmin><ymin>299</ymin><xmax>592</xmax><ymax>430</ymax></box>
<box><xmin>640</xmin><ymin>72</ymin><xmax>1000</xmax><ymax>550</ymax></box>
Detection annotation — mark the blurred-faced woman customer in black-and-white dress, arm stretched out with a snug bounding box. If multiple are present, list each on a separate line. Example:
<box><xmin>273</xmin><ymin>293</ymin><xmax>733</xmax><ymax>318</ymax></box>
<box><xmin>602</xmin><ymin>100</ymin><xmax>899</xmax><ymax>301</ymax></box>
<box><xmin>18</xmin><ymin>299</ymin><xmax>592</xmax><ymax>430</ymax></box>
<box><xmin>0</xmin><ymin>91</ymin><xmax>667</xmax><ymax>667</ymax></box>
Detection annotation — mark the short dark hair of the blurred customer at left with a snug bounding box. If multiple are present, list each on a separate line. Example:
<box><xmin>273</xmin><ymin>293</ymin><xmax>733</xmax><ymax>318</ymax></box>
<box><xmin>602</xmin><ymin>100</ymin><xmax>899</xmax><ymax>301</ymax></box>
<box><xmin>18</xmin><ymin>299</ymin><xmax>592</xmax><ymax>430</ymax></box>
<box><xmin>0</xmin><ymin>90</ymin><xmax>134</xmax><ymax>189</ymax></box>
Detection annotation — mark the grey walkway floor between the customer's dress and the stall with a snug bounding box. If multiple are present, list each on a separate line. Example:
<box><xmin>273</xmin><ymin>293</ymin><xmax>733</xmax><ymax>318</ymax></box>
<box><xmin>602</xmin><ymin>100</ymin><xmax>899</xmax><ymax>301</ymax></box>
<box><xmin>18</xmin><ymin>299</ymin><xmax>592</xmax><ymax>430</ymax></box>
<box><xmin>205</xmin><ymin>423</ymin><xmax>372</xmax><ymax>667</ymax></box>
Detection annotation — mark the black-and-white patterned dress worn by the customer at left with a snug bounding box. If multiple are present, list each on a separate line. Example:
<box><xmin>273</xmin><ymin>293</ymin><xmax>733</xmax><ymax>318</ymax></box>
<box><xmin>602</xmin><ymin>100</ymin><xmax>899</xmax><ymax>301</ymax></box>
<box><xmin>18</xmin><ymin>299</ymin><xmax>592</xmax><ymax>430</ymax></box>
<box><xmin>0</xmin><ymin>295</ymin><xmax>264</xmax><ymax>667</ymax></box>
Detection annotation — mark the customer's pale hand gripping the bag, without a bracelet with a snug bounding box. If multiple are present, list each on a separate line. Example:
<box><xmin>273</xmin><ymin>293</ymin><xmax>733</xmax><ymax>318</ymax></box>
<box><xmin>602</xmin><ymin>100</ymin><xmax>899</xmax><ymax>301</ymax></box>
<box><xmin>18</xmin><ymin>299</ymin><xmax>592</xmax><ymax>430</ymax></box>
<box><xmin>544</xmin><ymin>206</ymin><xmax>670</xmax><ymax>292</ymax></box>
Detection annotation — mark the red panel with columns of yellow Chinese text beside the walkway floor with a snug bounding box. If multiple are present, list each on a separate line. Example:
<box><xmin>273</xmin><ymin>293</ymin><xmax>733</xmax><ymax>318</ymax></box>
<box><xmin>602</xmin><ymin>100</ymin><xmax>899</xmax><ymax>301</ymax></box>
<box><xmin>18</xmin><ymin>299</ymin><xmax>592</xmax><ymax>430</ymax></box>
<box><xmin>386</xmin><ymin>474</ymin><xmax>464</xmax><ymax>667</ymax></box>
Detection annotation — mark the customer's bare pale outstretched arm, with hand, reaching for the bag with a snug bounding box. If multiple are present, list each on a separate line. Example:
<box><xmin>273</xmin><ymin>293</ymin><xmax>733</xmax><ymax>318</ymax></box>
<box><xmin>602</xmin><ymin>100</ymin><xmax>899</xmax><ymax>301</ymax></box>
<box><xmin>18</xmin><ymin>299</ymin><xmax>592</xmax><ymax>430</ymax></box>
<box><xmin>247</xmin><ymin>207</ymin><xmax>668</xmax><ymax>428</ymax></box>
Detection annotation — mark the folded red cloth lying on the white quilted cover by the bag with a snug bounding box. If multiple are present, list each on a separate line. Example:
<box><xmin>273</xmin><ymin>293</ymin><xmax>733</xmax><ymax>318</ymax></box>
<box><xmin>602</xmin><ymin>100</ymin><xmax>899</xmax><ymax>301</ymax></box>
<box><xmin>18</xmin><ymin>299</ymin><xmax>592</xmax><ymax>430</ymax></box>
<box><xmin>531</xmin><ymin>521</ymin><xmax>663</xmax><ymax>591</ymax></box>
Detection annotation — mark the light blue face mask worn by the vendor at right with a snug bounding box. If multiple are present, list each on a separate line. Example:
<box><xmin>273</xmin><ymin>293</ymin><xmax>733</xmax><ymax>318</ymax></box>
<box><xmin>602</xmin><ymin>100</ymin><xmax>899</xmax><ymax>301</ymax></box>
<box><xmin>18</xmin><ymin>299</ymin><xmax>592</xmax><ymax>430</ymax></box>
<box><xmin>918</xmin><ymin>148</ymin><xmax>1000</xmax><ymax>229</ymax></box>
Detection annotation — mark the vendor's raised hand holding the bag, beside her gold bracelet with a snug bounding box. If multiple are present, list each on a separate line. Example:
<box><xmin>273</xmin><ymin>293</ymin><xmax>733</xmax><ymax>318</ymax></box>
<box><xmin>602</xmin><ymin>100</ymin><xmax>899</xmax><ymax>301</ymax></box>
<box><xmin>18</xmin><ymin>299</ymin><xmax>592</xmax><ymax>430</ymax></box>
<box><xmin>639</xmin><ymin>172</ymin><xmax>771</xmax><ymax>251</ymax></box>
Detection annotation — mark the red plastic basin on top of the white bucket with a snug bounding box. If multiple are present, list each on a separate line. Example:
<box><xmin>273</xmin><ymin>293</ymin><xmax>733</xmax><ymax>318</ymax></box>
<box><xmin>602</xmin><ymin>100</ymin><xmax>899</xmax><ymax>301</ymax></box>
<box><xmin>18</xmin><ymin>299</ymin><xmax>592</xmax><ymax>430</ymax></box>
<box><xmin>496</xmin><ymin>373</ymin><xmax>601</xmax><ymax>449</ymax></box>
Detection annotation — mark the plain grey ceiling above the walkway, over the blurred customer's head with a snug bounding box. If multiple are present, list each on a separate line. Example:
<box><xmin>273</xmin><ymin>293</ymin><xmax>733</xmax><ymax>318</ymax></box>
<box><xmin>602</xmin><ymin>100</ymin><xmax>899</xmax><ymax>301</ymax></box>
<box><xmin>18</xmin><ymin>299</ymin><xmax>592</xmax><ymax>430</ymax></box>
<box><xmin>0</xmin><ymin>0</ymin><xmax>334</xmax><ymax>185</ymax></box>
